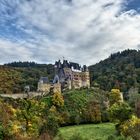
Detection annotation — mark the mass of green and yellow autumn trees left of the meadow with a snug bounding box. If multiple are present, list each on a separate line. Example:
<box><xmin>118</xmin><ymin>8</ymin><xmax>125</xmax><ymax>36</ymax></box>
<box><xmin>0</xmin><ymin>99</ymin><xmax>59</xmax><ymax>140</ymax></box>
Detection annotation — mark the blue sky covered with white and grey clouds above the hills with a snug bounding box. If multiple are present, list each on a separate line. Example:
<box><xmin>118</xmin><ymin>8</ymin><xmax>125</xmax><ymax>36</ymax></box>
<box><xmin>0</xmin><ymin>0</ymin><xmax>140</xmax><ymax>65</ymax></box>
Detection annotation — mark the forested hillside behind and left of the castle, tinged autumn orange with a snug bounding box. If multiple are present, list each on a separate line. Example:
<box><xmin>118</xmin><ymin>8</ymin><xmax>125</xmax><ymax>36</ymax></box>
<box><xmin>0</xmin><ymin>62</ymin><xmax>54</xmax><ymax>94</ymax></box>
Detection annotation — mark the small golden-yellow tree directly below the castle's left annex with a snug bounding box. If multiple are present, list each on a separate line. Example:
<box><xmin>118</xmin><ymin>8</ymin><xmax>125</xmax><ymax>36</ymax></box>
<box><xmin>52</xmin><ymin>92</ymin><xmax>64</xmax><ymax>107</ymax></box>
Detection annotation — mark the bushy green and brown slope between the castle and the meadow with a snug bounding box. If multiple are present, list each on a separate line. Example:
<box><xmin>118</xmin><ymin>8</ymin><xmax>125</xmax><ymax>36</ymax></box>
<box><xmin>41</xmin><ymin>88</ymin><xmax>109</xmax><ymax>126</ymax></box>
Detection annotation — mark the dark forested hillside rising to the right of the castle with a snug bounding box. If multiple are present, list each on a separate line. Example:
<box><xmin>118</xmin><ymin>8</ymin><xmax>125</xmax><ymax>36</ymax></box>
<box><xmin>89</xmin><ymin>50</ymin><xmax>140</xmax><ymax>92</ymax></box>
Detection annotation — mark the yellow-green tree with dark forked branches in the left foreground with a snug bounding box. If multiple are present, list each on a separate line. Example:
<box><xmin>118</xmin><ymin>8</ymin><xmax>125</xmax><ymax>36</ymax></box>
<box><xmin>17</xmin><ymin>99</ymin><xmax>45</xmax><ymax>136</ymax></box>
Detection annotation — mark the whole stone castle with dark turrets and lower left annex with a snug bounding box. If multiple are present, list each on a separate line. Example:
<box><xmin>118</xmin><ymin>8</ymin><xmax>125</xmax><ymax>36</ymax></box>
<box><xmin>38</xmin><ymin>60</ymin><xmax>90</xmax><ymax>93</ymax></box>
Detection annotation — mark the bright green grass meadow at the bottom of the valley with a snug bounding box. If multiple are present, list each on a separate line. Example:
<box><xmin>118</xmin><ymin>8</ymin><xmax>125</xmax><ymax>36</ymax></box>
<box><xmin>55</xmin><ymin>123</ymin><xmax>115</xmax><ymax>140</ymax></box>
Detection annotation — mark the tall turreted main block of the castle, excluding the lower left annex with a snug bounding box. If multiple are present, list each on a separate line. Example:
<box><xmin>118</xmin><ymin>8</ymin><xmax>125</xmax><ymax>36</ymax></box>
<box><xmin>55</xmin><ymin>60</ymin><xmax>90</xmax><ymax>89</ymax></box>
